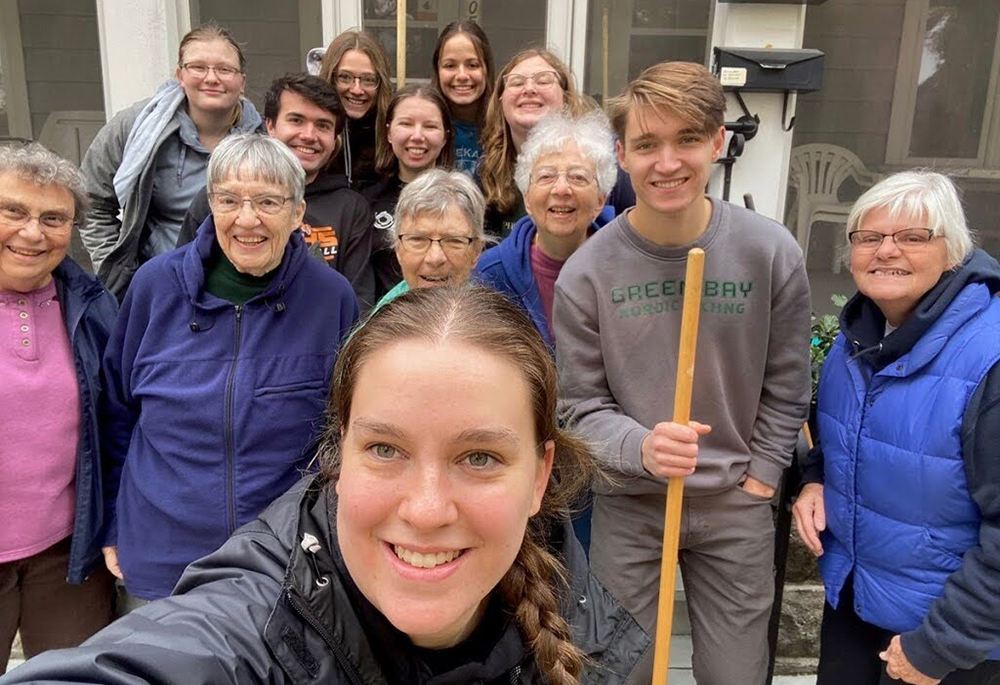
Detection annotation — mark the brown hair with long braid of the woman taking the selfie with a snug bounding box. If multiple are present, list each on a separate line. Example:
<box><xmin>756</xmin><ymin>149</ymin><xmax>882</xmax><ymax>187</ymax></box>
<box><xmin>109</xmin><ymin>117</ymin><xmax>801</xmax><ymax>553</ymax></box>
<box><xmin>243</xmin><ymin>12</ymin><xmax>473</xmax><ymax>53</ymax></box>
<box><xmin>318</xmin><ymin>286</ymin><xmax>599</xmax><ymax>685</ymax></box>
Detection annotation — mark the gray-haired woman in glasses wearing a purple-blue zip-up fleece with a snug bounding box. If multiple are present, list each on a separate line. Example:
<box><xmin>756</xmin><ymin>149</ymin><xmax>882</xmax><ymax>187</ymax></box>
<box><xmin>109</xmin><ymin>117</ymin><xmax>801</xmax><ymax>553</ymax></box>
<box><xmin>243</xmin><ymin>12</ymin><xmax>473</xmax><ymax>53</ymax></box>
<box><xmin>102</xmin><ymin>134</ymin><xmax>358</xmax><ymax>606</ymax></box>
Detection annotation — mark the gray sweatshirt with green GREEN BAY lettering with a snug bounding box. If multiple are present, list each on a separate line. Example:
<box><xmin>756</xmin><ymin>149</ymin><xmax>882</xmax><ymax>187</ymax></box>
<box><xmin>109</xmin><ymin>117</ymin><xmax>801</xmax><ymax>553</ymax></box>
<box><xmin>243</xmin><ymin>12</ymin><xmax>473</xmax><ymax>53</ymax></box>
<box><xmin>553</xmin><ymin>199</ymin><xmax>810</xmax><ymax>496</ymax></box>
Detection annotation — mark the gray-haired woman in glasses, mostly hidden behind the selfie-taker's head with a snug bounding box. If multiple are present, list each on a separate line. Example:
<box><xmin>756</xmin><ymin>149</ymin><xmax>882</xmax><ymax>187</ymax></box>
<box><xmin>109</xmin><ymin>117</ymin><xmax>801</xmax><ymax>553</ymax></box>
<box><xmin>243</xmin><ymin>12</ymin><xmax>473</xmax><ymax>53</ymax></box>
<box><xmin>376</xmin><ymin>169</ymin><xmax>486</xmax><ymax>309</ymax></box>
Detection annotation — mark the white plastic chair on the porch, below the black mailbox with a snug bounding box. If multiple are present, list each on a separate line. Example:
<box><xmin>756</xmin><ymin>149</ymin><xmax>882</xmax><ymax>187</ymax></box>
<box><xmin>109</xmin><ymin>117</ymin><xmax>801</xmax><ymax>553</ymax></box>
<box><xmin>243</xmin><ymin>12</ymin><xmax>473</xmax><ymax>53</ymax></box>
<box><xmin>788</xmin><ymin>143</ymin><xmax>875</xmax><ymax>274</ymax></box>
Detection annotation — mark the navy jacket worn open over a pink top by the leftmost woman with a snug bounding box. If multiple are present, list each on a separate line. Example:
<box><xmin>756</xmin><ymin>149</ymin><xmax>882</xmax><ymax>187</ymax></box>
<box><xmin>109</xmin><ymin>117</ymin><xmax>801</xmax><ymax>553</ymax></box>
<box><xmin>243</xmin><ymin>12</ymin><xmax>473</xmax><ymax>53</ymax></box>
<box><xmin>52</xmin><ymin>257</ymin><xmax>118</xmax><ymax>584</ymax></box>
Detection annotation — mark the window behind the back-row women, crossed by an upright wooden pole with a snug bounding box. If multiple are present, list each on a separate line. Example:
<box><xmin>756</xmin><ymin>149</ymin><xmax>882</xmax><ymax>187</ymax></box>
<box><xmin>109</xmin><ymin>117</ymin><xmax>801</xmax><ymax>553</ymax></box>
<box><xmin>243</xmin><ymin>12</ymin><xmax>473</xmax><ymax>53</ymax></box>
<box><xmin>364</xmin><ymin>0</ymin><xmax>546</xmax><ymax>79</ymax></box>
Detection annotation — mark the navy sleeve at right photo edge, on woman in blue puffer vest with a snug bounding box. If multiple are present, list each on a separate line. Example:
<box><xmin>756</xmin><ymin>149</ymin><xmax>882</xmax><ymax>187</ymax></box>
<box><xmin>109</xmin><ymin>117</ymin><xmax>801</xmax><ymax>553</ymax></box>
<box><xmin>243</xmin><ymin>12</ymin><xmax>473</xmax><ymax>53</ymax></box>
<box><xmin>900</xmin><ymin>364</ymin><xmax>1000</xmax><ymax>678</ymax></box>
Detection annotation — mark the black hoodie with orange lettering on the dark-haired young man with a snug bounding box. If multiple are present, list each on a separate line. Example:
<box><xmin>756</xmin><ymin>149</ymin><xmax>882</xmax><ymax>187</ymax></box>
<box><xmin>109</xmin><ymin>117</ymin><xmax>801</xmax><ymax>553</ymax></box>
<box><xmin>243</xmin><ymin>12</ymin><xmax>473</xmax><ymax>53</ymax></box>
<box><xmin>177</xmin><ymin>172</ymin><xmax>377</xmax><ymax>310</ymax></box>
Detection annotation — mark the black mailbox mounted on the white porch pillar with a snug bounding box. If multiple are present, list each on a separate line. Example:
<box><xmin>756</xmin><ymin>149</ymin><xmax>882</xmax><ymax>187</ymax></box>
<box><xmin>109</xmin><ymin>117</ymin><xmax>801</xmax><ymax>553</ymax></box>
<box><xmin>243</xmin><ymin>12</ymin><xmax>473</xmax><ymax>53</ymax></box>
<box><xmin>714</xmin><ymin>47</ymin><xmax>824</xmax><ymax>93</ymax></box>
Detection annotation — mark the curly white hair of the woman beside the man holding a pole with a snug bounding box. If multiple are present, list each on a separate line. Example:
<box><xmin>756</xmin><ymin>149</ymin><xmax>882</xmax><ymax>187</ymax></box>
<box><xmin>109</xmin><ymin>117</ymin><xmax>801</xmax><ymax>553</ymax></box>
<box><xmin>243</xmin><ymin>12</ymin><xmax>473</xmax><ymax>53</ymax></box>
<box><xmin>514</xmin><ymin>110</ymin><xmax>618</xmax><ymax>197</ymax></box>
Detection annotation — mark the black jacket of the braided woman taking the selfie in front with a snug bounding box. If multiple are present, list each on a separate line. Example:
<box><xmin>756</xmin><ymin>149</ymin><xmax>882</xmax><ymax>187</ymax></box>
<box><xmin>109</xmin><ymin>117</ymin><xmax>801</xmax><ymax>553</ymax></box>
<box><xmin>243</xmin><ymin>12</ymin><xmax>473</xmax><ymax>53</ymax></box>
<box><xmin>0</xmin><ymin>477</ymin><xmax>650</xmax><ymax>685</ymax></box>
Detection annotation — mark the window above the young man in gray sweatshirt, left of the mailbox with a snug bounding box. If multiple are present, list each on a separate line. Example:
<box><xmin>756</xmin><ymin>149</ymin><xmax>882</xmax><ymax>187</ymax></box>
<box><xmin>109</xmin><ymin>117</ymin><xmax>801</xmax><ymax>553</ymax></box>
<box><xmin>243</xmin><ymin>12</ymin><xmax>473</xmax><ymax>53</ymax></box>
<box><xmin>584</xmin><ymin>0</ymin><xmax>712</xmax><ymax>99</ymax></box>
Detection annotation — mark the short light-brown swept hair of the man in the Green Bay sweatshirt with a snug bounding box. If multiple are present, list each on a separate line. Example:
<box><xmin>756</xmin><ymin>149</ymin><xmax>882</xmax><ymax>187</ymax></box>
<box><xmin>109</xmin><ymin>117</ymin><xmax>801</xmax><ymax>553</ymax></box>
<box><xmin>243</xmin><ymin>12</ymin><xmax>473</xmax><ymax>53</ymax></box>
<box><xmin>608</xmin><ymin>62</ymin><xmax>726</xmax><ymax>143</ymax></box>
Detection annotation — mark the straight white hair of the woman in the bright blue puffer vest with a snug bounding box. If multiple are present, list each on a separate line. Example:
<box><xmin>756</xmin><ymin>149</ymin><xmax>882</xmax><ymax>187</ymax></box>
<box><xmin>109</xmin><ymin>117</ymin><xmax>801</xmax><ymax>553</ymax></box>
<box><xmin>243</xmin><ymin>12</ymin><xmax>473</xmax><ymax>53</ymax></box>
<box><xmin>846</xmin><ymin>169</ymin><xmax>975</xmax><ymax>267</ymax></box>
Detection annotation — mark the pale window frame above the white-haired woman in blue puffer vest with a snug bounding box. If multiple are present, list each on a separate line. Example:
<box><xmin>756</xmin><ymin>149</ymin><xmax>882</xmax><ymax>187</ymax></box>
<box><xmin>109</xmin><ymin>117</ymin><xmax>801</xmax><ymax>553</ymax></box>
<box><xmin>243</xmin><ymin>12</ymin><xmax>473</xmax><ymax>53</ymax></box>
<box><xmin>885</xmin><ymin>0</ymin><xmax>1000</xmax><ymax>169</ymax></box>
